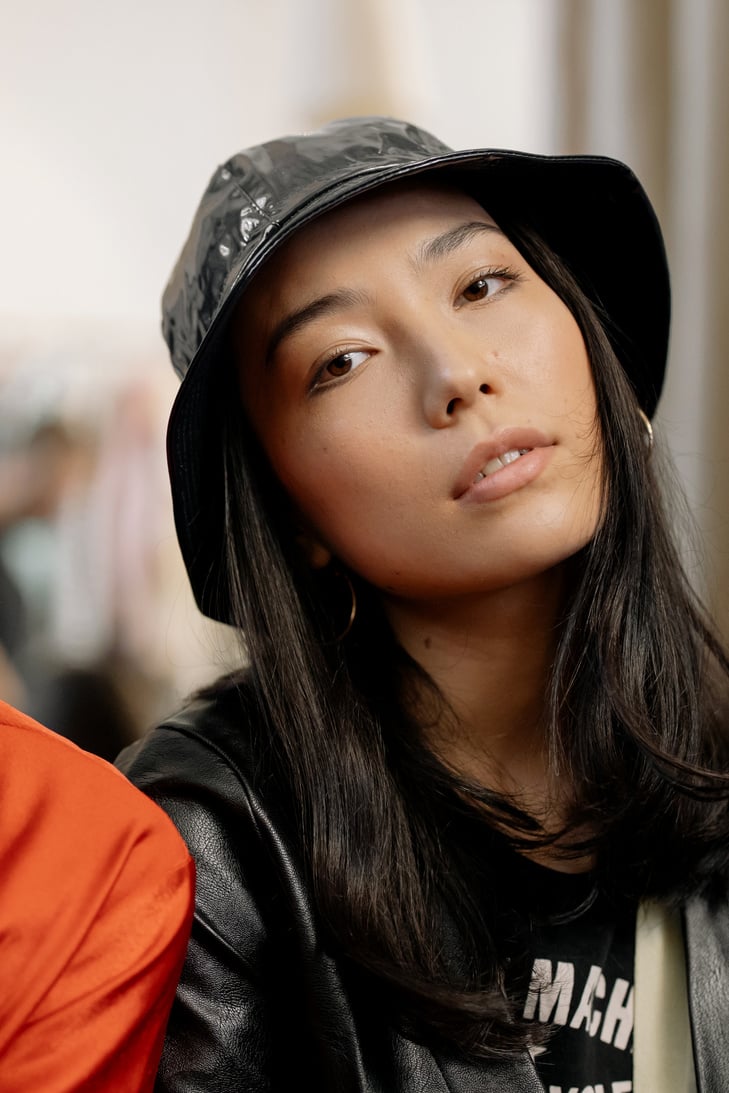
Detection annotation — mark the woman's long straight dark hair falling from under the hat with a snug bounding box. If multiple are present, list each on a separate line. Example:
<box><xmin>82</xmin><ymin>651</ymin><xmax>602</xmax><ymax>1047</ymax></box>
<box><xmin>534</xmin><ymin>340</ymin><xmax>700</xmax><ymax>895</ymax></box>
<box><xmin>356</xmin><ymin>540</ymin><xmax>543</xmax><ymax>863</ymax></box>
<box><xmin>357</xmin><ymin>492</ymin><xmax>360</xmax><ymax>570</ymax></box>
<box><xmin>202</xmin><ymin>218</ymin><xmax>729</xmax><ymax>1057</ymax></box>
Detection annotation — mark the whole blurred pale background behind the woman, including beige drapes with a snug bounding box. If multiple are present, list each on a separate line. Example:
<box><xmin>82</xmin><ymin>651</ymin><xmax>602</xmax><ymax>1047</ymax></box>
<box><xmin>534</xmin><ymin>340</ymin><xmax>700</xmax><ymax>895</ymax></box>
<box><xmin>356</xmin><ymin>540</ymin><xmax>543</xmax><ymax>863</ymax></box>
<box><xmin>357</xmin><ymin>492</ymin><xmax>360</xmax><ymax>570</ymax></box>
<box><xmin>0</xmin><ymin>0</ymin><xmax>729</xmax><ymax>755</ymax></box>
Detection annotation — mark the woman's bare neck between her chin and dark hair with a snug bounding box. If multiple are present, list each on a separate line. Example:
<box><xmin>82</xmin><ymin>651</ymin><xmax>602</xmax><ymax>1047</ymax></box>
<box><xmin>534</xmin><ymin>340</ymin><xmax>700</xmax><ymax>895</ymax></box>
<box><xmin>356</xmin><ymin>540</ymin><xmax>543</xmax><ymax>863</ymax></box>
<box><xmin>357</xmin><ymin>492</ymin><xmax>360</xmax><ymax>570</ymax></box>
<box><xmin>386</xmin><ymin>567</ymin><xmax>566</xmax><ymax>818</ymax></box>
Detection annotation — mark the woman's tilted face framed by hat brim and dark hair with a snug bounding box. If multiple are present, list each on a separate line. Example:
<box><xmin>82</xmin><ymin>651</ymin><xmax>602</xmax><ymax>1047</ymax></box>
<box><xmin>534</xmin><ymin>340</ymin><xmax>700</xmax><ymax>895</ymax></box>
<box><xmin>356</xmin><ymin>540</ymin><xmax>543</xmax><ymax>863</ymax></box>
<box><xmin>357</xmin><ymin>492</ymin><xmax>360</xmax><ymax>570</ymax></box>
<box><xmin>233</xmin><ymin>186</ymin><xmax>600</xmax><ymax>600</ymax></box>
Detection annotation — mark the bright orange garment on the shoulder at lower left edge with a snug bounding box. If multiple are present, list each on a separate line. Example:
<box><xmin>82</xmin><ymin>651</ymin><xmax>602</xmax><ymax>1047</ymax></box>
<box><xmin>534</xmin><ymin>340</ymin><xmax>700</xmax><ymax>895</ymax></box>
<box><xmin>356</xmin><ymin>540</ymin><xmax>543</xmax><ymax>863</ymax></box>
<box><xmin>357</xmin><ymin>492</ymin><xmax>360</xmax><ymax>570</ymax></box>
<box><xmin>0</xmin><ymin>702</ymin><xmax>193</xmax><ymax>1093</ymax></box>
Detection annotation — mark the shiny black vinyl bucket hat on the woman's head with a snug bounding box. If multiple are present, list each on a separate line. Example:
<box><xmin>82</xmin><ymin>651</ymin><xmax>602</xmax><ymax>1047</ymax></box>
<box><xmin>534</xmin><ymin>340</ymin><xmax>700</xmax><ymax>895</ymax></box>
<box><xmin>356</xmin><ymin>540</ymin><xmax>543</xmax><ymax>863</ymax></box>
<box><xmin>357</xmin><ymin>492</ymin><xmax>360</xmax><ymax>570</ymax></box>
<box><xmin>163</xmin><ymin>117</ymin><xmax>670</xmax><ymax>622</ymax></box>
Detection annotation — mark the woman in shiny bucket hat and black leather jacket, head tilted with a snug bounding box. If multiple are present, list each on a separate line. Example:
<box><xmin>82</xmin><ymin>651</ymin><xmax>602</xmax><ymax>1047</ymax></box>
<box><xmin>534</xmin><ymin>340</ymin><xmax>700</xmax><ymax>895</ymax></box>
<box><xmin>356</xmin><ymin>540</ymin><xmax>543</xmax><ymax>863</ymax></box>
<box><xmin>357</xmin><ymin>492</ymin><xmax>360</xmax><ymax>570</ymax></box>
<box><xmin>116</xmin><ymin>118</ymin><xmax>729</xmax><ymax>1093</ymax></box>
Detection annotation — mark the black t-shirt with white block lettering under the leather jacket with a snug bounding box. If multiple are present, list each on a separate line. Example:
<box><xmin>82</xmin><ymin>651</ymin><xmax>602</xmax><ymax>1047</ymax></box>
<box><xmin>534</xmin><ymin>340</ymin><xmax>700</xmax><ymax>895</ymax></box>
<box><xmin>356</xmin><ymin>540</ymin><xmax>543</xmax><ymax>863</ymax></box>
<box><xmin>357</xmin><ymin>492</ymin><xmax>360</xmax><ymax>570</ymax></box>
<box><xmin>513</xmin><ymin>855</ymin><xmax>636</xmax><ymax>1093</ymax></box>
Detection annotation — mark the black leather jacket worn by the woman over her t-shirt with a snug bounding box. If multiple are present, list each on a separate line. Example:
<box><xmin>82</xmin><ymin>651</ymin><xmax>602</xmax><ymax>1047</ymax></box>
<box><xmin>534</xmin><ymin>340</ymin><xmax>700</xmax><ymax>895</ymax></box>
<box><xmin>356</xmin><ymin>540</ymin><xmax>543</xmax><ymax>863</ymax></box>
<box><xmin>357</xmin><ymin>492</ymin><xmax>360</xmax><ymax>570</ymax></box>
<box><xmin>118</xmin><ymin>698</ymin><xmax>729</xmax><ymax>1093</ymax></box>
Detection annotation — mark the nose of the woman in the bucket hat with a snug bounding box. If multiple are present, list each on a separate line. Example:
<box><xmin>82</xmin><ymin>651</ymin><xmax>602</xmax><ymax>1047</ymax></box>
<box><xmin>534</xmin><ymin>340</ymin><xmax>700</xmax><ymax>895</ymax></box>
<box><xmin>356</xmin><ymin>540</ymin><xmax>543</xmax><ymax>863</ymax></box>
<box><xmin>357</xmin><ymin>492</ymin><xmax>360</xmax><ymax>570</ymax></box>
<box><xmin>423</xmin><ymin>343</ymin><xmax>492</xmax><ymax>428</ymax></box>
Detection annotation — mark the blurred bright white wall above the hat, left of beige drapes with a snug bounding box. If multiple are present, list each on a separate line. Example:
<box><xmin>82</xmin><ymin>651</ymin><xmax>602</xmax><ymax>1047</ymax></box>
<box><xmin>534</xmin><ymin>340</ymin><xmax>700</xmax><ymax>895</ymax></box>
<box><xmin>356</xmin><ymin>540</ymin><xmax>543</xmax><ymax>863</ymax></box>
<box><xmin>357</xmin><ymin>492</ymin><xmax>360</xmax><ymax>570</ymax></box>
<box><xmin>0</xmin><ymin>0</ymin><xmax>554</xmax><ymax>330</ymax></box>
